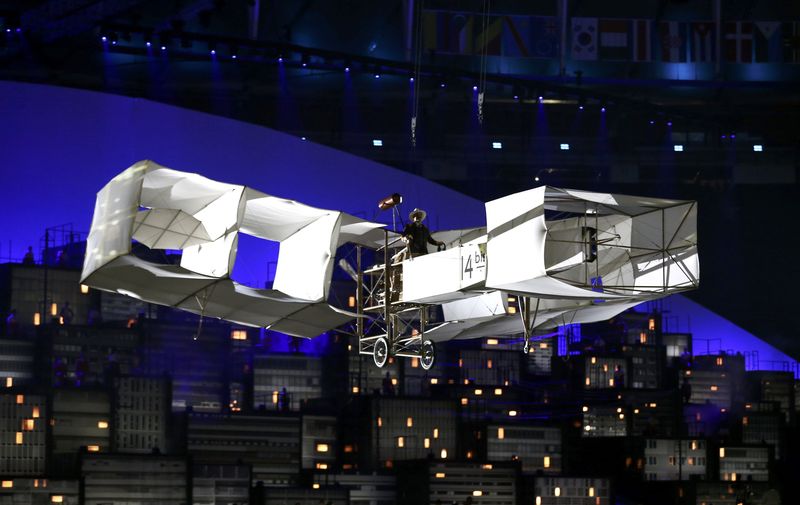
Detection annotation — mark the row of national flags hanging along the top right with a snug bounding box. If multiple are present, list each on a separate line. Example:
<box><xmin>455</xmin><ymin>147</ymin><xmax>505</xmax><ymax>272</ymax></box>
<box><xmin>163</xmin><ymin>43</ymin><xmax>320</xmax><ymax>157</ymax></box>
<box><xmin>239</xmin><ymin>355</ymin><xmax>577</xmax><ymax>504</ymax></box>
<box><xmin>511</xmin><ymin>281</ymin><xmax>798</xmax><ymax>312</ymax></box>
<box><xmin>422</xmin><ymin>10</ymin><xmax>800</xmax><ymax>63</ymax></box>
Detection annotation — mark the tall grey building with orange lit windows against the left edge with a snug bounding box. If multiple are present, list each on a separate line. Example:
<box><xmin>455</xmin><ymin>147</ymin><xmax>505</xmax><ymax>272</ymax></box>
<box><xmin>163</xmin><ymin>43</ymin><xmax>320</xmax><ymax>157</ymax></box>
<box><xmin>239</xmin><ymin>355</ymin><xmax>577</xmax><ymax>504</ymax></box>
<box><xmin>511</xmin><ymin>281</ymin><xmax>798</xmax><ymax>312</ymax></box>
<box><xmin>0</xmin><ymin>389</ymin><xmax>47</xmax><ymax>476</ymax></box>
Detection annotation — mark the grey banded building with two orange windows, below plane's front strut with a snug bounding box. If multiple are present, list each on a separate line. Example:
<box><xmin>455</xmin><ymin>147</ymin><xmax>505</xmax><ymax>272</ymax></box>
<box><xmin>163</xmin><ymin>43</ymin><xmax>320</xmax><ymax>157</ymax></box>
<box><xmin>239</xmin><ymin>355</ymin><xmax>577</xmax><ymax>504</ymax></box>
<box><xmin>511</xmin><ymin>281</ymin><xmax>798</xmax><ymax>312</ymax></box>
<box><xmin>486</xmin><ymin>424</ymin><xmax>562</xmax><ymax>474</ymax></box>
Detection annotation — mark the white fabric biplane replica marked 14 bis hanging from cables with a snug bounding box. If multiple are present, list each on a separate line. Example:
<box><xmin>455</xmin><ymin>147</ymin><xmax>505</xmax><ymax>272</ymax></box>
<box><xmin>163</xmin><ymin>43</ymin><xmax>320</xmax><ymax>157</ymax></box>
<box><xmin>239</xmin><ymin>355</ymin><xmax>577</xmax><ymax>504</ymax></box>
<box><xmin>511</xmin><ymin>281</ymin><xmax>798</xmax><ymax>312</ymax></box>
<box><xmin>81</xmin><ymin>161</ymin><xmax>700</xmax><ymax>369</ymax></box>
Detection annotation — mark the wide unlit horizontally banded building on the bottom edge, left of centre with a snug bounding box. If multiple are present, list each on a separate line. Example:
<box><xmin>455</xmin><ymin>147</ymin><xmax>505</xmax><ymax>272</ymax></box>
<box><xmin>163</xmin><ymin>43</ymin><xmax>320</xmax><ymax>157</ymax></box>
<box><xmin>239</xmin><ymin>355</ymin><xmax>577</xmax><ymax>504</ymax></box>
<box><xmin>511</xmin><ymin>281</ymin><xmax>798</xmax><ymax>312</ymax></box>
<box><xmin>80</xmin><ymin>454</ymin><xmax>190</xmax><ymax>505</ymax></box>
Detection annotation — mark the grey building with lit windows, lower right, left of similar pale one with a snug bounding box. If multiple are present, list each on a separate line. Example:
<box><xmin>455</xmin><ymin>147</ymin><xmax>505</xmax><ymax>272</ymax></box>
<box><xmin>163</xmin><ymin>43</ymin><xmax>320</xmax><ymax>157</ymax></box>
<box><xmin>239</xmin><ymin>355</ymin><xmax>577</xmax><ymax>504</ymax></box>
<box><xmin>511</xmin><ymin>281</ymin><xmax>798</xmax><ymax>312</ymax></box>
<box><xmin>644</xmin><ymin>438</ymin><xmax>708</xmax><ymax>480</ymax></box>
